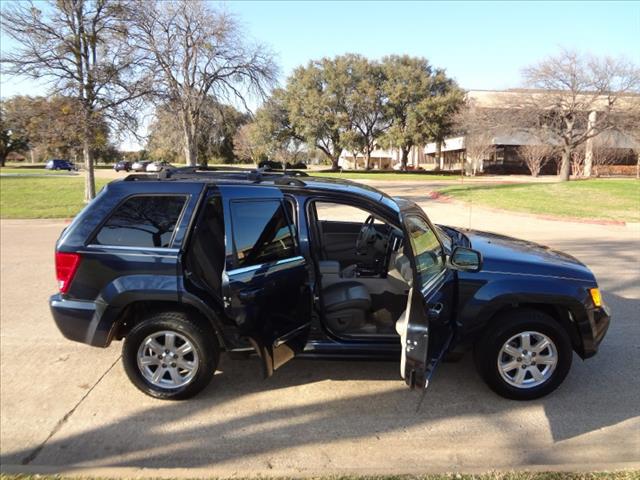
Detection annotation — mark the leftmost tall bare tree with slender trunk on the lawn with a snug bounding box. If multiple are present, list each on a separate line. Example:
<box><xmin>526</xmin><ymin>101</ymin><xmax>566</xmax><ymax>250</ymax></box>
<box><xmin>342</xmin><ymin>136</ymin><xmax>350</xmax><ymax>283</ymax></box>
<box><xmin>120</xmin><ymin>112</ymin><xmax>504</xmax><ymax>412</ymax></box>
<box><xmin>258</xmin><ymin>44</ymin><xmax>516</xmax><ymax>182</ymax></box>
<box><xmin>0</xmin><ymin>0</ymin><xmax>144</xmax><ymax>201</ymax></box>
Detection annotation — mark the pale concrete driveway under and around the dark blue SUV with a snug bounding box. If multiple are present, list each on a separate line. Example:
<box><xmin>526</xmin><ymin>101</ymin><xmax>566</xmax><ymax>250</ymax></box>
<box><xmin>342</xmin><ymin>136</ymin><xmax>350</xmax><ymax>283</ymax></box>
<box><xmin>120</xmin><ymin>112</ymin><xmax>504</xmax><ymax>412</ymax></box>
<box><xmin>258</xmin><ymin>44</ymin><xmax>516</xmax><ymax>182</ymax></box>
<box><xmin>0</xmin><ymin>185</ymin><xmax>640</xmax><ymax>476</ymax></box>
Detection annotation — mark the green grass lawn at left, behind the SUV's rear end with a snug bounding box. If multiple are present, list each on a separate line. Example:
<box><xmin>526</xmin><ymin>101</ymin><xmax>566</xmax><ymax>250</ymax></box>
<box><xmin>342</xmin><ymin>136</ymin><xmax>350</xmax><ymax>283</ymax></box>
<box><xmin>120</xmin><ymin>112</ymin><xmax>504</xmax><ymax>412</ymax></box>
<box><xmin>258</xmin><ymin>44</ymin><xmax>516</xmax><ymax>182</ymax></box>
<box><xmin>0</xmin><ymin>175</ymin><xmax>108</xmax><ymax>218</ymax></box>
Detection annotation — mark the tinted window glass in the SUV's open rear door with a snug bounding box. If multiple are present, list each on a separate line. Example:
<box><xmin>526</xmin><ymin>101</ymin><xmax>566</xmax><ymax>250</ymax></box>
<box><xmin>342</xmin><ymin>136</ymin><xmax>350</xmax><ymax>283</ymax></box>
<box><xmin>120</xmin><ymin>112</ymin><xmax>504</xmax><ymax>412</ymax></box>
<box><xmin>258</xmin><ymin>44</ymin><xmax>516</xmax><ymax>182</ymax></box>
<box><xmin>231</xmin><ymin>200</ymin><xmax>295</xmax><ymax>267</ymax></box>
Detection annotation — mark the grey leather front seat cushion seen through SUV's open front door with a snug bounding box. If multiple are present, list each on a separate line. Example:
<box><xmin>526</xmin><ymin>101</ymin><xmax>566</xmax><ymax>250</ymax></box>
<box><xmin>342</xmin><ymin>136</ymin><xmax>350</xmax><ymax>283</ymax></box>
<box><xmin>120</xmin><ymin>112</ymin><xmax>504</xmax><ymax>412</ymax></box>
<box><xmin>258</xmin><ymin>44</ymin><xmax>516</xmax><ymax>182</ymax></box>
<box><xmin>322</xmin><ymin>282</ymin><xmax>376</xmax><ymax>333</ymax></box>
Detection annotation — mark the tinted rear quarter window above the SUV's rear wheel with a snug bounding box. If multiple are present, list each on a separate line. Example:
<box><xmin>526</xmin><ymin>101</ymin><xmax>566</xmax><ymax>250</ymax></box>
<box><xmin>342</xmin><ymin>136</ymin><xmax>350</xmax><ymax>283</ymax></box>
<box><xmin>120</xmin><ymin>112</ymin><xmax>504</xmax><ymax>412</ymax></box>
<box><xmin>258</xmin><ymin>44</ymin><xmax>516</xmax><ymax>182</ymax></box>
<box><xmin>93</xmin><ymin>195</ymin><xmax>187</xmax><ymax>248</ymax></box>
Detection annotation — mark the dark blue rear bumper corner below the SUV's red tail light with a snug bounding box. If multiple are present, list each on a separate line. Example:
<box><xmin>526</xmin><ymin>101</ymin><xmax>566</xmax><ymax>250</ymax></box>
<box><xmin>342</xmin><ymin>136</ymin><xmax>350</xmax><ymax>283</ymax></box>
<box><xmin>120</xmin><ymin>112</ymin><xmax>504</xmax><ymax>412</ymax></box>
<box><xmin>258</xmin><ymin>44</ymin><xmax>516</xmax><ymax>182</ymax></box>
<box><xmin>49</xmin><ymin>293</ymin><xmax>109</xmax><ymax>347</ymax></box>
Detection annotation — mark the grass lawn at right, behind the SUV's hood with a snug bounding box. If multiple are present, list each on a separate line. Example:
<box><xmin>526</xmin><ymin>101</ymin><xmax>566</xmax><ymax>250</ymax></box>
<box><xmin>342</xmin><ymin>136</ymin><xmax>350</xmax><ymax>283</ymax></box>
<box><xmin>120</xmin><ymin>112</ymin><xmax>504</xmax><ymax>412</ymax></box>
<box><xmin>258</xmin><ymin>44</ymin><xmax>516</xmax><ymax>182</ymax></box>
<box><xmin>439</xmin><ymin>179</ymin><xmax>640</xmax><ymax>222</ymax></box>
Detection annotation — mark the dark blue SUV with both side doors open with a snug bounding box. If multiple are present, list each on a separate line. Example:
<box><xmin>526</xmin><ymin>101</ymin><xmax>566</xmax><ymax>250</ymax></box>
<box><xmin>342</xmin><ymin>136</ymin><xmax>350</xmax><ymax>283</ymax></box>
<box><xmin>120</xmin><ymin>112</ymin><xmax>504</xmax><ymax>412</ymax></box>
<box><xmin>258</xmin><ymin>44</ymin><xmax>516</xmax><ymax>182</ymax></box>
<box><xmin>50</xmin><ymin>169</ymin><xmax>609</xmax><ymax>399</ymax></box>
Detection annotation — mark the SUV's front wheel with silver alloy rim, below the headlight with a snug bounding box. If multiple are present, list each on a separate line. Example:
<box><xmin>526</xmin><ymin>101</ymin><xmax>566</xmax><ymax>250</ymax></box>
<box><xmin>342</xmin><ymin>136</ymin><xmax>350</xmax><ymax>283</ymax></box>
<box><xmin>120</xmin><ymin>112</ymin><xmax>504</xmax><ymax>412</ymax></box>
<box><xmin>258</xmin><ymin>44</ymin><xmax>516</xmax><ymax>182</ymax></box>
<box><xmin>475</xmin><ymin>310</ymin><xmax>573</xmax><ymax>400</ymax></box>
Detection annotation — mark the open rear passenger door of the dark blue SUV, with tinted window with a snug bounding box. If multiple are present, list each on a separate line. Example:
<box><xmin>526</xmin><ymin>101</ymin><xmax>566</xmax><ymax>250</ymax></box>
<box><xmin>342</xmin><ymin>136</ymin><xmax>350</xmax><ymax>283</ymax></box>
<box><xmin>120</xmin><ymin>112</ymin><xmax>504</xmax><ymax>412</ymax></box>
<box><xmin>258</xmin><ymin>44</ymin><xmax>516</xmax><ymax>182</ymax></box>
<box><xmin>220</xmin><ymin>186</ymin><xmax>313</xmax><ymax>377</ymax></box>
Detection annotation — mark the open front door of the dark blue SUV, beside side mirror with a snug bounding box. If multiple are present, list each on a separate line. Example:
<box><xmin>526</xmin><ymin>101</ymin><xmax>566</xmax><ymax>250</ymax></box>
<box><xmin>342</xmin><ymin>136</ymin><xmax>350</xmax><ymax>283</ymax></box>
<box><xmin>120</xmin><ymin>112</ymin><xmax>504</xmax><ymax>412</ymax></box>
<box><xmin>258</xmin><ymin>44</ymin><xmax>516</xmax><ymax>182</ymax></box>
<box><xmin>398</xmin><ymin>210</ymin><xmax>455</xmax><ymax>388</ymax></box>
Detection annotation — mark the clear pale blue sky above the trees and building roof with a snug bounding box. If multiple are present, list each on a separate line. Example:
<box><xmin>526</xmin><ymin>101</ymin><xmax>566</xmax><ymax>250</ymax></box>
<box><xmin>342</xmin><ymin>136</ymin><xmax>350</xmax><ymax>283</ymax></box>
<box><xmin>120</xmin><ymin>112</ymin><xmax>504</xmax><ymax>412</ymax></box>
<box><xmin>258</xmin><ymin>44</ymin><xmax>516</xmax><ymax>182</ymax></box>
<box><xmin>0</xmin><ymin>1</ymin><xmax>640</xmax><ymax>149</ymax></box>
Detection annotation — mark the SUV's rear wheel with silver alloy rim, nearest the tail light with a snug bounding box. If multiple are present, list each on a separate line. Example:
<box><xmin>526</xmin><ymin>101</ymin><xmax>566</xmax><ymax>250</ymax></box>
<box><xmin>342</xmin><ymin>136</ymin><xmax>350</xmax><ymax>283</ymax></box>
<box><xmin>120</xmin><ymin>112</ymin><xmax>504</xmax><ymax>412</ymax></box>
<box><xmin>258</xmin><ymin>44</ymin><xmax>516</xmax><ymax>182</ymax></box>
<box><xmin>122</xmin><ymin>312</ymin><xmax>220</xmax><ymax>400</ymax></box>
